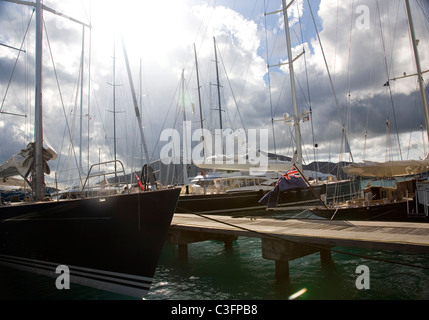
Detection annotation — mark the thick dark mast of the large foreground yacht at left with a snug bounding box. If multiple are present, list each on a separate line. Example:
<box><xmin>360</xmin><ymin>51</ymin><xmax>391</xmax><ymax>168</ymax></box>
<box><xmin>33</xmin><ymin>0</ymin><xmax>45</xmax><ymax>201</ymax></box>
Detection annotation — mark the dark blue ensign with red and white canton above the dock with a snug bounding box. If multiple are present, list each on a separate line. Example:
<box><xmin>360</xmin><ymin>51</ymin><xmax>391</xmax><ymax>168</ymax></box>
<box><xmin>259</xmin><ymin>166</ymin><xmax>307</xmax><ymax>208</ymax></box>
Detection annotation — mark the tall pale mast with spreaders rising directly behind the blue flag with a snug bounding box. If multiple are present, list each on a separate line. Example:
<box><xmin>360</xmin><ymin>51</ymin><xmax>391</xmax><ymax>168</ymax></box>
<box><xmin>282</xmin><ymin>0</ymin><xmax>302</xmax><ymax>172</ymax></box>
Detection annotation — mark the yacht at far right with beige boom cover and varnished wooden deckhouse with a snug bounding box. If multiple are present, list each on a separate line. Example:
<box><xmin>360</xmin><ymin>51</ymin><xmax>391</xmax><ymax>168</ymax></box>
<box><xmin>310</xmin><ymin>0</ymin><xmax>429</xmax><ymax>221</ymax></box>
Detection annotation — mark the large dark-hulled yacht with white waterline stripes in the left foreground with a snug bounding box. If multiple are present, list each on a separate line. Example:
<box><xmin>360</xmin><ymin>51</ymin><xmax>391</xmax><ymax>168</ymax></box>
<box><xmin>0</xmin><ymin>0</ymin><xmax>180</xmax><ymax>298</ymax></box>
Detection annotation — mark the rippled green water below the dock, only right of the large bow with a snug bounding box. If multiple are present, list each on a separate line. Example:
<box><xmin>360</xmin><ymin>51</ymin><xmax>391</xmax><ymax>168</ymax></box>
<box><xmin>146</xmin><ymin>238</ymin><xmax>429</xmax><ymax>300</ymax></box>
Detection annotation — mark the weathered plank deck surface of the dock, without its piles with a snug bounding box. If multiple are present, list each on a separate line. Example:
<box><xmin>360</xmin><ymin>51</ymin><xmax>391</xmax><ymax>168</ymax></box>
<box><xmin>171</xmin><ymin>214</ymin><xmax>429</xmax><ymax>253</ymax></box>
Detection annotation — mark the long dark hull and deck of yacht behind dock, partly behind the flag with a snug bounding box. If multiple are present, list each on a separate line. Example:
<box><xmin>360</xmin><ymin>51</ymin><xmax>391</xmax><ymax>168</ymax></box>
<box><xmin>176</xmin><ymin>159</ymin><xmax>357</xmax><ymax>215</ymax></box>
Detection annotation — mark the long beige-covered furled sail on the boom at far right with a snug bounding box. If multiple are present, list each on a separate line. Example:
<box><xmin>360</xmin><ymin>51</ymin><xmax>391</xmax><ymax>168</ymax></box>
<box><xmin>343</xmin><ymin>156</ymin><xmax>429</xmax><ymax>178</ymax></box>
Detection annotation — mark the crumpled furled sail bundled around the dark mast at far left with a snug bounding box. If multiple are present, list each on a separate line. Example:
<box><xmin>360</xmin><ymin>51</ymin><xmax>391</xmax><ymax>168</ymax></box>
<box><xmin>0</xmin><ymin>142</ymin><xmax>58</xmax><ymax>178</ymax></box>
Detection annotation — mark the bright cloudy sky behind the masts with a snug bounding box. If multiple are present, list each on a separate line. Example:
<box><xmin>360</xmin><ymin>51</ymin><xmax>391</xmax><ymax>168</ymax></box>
<box><xmin>0</xmin><ymin>0</ymin><xmax>429</xmax><ymax>185</ymax></box>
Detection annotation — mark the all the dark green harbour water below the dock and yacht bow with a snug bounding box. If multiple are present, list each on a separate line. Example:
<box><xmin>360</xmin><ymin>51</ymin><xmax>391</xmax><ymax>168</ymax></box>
<box><xmin>0</xmin><ymin>210</ymin><xmax>429</xmax><ymax>301</ymax></box>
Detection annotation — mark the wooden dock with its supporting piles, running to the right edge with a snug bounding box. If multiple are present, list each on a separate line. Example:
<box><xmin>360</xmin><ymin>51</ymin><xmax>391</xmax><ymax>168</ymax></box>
<box><xmin>169</xmin><ymin>214</ymin><xmax>429</xmax><ymax>278</ymax></box>
